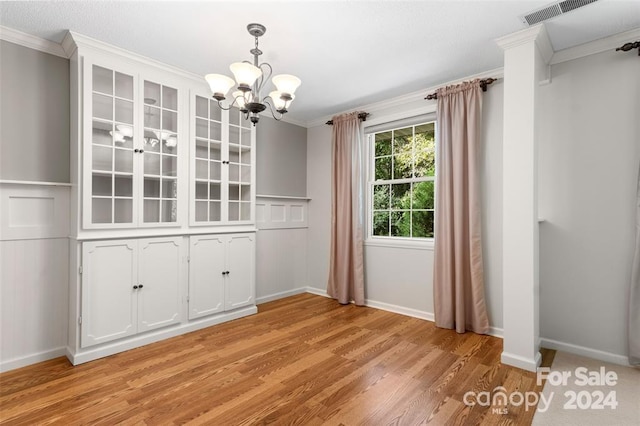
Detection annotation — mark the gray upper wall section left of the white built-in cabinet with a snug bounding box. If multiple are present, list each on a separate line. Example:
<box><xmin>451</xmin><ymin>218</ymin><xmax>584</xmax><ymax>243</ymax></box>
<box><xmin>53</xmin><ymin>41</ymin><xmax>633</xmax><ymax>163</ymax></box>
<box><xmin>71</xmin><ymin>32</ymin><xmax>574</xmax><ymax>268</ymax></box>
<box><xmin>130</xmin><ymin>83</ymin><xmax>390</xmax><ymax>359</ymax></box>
<box><xmin>0</xmin><ymin>41</ymin><xmax>69</xmax><ymax>182</ymax></box>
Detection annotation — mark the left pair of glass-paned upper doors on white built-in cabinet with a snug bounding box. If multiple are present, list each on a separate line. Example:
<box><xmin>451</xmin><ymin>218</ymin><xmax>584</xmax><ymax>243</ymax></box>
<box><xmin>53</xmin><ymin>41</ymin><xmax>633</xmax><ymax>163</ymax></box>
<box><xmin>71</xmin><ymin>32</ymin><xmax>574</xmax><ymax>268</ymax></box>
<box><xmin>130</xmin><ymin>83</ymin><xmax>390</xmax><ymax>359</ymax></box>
<box><xmin>82</xmin><ymin>57</ymin><xmax>188</xmax><ymax>229</ymax></box>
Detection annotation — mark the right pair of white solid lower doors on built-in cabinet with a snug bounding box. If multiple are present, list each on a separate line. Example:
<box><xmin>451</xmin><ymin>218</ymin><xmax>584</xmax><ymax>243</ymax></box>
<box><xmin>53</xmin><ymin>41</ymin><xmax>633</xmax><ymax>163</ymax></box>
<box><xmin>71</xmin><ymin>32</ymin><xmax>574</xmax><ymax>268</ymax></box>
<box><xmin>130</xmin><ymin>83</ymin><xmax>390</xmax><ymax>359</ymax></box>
<box><xmin>189</xmin><ymin>233</ymin><xmax>255</xmax><ymax>319</ymax></box>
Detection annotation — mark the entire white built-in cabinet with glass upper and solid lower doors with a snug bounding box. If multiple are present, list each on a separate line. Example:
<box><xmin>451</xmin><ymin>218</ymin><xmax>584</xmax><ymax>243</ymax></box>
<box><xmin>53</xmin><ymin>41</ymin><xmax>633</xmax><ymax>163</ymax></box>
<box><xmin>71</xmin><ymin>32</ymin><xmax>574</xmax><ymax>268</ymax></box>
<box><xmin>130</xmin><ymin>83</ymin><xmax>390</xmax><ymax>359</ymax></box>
<box><xmin>63</xmin><ymin>32</ymin><xmax>257</xmax><ymax>364</ymax></box>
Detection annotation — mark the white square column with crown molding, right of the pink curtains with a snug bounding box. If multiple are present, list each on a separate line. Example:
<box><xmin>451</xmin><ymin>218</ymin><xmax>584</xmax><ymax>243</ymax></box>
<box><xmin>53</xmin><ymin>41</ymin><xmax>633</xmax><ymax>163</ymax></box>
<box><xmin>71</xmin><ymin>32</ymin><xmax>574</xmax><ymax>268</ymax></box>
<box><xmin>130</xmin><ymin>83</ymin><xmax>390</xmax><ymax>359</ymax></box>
<box><xmin>496</xmin><ymin>24</ymin><xmax>553</xmax><ymax>371</ymax></box>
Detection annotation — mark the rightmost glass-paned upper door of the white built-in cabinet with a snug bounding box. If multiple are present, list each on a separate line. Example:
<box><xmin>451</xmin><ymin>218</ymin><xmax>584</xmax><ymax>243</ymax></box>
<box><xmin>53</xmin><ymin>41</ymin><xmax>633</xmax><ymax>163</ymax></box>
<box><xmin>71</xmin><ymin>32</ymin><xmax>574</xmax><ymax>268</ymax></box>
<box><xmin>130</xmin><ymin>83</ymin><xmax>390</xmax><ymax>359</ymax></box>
<box><xmin>227</xmin><ymin>108</ymin><xmax>253</xmax><ymax>222</ymax></box>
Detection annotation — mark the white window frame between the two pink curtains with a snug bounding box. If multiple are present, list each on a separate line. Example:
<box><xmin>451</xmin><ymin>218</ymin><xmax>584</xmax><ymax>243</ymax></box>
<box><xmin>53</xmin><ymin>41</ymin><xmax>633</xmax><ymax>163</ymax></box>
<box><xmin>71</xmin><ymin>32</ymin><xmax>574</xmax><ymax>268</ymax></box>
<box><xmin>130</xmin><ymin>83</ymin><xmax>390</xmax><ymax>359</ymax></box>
<box><xmin>364</xmin><ymin>116</ymin><xmax>438</xmax><ymax>250</ymax></box>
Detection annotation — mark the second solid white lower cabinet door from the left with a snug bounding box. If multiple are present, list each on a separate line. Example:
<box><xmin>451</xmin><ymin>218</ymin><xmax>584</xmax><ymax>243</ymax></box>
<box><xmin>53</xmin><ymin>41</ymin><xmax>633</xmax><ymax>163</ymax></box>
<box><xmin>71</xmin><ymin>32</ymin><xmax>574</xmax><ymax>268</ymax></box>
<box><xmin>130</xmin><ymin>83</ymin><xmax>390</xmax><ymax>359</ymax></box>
<box><xmin>137</xmin><ymin>238</ymin><xmax>182</xmax><ymax>332</ymax></box>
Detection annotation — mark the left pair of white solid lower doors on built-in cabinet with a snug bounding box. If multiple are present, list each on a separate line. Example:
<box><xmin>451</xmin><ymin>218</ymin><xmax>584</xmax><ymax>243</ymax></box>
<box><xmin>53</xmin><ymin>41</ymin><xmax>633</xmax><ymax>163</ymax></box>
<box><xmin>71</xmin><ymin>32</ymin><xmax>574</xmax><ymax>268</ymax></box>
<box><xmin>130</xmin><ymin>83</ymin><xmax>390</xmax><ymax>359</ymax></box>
<box><xmin>80</xmin><ymin>237</ymin><xmax>183</xmax><ymax>347</ymax></box>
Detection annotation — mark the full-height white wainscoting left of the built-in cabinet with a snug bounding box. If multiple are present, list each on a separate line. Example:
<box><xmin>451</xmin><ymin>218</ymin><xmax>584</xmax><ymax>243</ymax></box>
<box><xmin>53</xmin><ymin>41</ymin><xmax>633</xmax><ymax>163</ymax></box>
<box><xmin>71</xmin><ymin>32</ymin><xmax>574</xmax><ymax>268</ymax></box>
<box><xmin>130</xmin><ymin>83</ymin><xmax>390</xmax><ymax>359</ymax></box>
<box><xmin>0</xmin><ymin>181</ymin><xmax>71</xmax><ymax>371</ymax></box>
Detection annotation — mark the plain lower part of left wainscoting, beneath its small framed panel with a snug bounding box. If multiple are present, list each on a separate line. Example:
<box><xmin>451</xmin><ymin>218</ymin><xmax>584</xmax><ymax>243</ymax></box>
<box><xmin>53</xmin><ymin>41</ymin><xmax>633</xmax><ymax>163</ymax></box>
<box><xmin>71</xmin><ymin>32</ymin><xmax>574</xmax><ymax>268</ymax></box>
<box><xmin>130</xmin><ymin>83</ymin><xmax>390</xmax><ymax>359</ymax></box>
<box><xmin>0</xmin><ymin>238</ymin><xmax>69</xmax><ymax>371</ymax></box>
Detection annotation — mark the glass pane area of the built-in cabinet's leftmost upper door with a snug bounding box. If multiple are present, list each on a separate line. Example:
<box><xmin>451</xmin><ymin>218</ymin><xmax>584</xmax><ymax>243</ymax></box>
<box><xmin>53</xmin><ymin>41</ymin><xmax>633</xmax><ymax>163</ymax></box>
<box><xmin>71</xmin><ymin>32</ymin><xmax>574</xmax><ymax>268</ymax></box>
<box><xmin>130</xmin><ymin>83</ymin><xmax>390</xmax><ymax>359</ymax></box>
<box><xmin>84</xmin><ymin>64</ymin><xmax>136</xmax><ymax>226</ymax></box>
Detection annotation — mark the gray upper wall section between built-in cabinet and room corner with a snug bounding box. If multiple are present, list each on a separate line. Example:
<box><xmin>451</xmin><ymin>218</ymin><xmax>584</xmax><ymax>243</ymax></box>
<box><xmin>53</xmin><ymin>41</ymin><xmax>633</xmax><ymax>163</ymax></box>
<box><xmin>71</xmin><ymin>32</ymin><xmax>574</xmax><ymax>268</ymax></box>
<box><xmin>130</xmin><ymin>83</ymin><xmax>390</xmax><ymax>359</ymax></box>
<box><xmin>256</xmin><ymin>117</ymin><xmax>307</xmax><ymax>197</ymax></box>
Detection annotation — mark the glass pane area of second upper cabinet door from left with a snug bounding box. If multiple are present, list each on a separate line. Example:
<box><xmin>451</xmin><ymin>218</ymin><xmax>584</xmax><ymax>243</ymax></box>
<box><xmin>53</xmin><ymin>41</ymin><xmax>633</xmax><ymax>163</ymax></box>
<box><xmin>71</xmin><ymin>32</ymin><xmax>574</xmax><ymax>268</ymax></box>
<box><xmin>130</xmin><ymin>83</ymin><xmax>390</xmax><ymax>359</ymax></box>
<box><xmin>141</xmin><ymin>80</ymin><xmax>183</xmax><ymax>224</ymax></box>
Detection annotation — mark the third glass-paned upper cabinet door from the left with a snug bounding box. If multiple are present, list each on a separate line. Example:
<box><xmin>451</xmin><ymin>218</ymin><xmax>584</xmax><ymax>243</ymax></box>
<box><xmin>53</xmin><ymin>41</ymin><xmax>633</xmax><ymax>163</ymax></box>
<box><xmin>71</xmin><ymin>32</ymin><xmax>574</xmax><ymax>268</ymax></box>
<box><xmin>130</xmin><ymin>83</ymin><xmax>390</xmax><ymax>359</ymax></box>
<box><xmin>192</xmin><ymin>96</ymin><xmax>223</xmax><ymax>224</ymax></box>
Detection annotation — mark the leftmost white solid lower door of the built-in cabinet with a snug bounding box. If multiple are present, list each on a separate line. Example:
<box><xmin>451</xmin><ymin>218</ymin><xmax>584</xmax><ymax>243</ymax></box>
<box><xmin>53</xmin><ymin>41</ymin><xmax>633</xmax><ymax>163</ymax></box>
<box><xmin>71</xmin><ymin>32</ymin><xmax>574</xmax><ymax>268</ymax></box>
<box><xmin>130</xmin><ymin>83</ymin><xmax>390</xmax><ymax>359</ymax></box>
<box><xmin>81</xmin><ymin>240</ymin><xmax>138</xmax><ymax>347</ymax></box>
